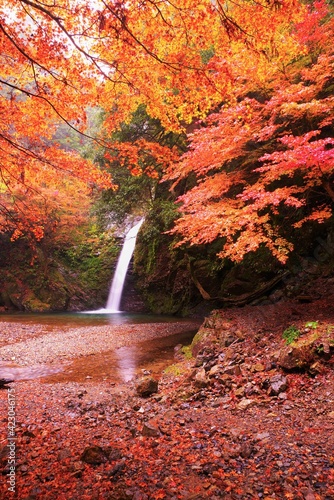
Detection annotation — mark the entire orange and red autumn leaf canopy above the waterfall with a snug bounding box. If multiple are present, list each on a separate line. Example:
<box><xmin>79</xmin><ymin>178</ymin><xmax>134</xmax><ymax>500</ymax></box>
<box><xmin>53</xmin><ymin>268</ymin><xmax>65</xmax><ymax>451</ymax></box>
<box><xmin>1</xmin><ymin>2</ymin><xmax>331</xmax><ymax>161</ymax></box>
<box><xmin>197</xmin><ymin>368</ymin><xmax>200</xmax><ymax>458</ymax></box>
<box><xmin>0</xmin><ymin>0</ymin><xmax>334</xmax><ymax>262</ymax></box>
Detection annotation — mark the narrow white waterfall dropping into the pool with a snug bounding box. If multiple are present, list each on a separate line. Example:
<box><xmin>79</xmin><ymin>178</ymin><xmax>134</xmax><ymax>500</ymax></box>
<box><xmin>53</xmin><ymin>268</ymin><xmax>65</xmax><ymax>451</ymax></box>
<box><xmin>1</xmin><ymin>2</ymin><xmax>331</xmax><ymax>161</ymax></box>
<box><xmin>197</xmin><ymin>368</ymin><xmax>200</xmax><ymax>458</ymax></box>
<box><xmin>105</xmin><ymin>219</ymin><xmax>144</xmax><ymax>313</ymax></box>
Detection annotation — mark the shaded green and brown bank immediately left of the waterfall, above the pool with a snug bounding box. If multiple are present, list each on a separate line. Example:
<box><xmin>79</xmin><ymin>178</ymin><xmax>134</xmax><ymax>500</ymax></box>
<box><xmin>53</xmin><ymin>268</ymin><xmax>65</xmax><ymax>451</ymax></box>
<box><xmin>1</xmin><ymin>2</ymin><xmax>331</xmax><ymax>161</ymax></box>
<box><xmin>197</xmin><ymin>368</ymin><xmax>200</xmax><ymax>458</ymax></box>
<box><xmin>0</xmin><ymin>216</ymin><xmax>120</xmax><ymax>312</ymax></box>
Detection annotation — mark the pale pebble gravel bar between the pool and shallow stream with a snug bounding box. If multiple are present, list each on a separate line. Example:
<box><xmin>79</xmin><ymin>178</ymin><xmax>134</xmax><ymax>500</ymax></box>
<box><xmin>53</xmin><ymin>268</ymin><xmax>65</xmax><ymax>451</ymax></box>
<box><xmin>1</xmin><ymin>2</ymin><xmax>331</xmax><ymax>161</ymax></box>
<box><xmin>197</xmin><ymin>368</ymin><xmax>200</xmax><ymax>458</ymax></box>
<box><xmin>0</xmin><ymin>321</ymin><xmax>198</xmax><ymax>368</ymax></box>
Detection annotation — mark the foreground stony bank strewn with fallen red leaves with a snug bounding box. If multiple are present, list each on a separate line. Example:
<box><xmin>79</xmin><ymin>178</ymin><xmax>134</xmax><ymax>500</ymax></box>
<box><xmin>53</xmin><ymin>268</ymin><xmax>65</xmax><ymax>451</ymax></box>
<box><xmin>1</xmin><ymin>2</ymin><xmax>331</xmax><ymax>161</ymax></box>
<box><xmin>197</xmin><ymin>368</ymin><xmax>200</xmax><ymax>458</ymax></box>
<box><xmin>0</xmin><ymin>297</ymin><xmax>334</xmax><ymax>500</ymax></box>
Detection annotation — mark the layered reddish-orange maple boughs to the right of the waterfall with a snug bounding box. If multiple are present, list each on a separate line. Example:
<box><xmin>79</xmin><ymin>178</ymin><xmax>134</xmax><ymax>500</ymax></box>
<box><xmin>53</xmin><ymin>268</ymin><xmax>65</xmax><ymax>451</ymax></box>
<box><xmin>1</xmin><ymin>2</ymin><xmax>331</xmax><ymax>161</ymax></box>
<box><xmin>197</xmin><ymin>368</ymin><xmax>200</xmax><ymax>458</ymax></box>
<box><xmin>166</xmin><ymin>2</ymin><xmax>334</xmax><ymax>262</ymax></box>
